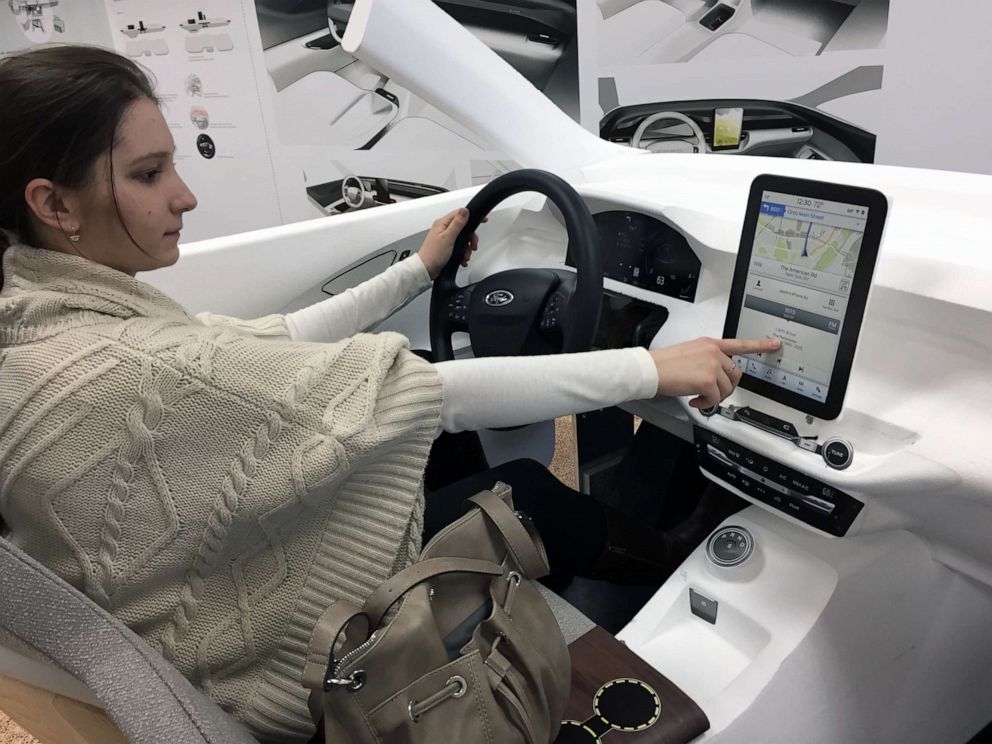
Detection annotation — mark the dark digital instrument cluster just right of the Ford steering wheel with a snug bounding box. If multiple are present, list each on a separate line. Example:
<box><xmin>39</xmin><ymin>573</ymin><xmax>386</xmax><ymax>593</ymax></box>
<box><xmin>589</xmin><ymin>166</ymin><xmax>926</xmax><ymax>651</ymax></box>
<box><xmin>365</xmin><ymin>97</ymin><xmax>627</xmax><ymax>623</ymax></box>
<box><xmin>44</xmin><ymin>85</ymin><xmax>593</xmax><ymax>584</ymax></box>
<box><xmin>566</xmin><ymin>211</ymin><xmax>701</xmax><ymax>302</ymax></box>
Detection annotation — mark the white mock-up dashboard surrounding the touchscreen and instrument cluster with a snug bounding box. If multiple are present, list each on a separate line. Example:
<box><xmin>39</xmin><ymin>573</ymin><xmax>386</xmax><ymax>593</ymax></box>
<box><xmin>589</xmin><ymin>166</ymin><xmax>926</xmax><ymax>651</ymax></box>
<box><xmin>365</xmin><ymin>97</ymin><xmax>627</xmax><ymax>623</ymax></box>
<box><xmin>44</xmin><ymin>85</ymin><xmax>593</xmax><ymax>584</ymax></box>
<box><xmin>438</xmin><ymin>155</ymin><xmax>992</xmax><ymax>584</ymax></box>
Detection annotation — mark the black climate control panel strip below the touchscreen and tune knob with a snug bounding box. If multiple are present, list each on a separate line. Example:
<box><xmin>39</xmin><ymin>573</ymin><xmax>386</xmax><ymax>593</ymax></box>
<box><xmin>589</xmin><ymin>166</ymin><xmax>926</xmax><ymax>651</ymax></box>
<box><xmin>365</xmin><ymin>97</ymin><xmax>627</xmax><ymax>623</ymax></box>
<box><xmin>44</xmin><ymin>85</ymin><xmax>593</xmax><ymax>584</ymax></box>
<box><xmin>694</xmin><ymin>426</ymin><xmax>864</xmax><ymax>537</ymax></box>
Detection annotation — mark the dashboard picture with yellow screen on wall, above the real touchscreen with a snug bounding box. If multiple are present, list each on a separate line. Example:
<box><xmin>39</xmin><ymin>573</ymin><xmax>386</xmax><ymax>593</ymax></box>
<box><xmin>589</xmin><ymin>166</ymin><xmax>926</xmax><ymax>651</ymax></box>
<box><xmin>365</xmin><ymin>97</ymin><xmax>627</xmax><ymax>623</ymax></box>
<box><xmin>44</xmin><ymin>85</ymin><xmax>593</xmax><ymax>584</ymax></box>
<box><xmin>599</xmin><ymin>99</ymin><xmax>875</xmax><ymax>163</ymax></box>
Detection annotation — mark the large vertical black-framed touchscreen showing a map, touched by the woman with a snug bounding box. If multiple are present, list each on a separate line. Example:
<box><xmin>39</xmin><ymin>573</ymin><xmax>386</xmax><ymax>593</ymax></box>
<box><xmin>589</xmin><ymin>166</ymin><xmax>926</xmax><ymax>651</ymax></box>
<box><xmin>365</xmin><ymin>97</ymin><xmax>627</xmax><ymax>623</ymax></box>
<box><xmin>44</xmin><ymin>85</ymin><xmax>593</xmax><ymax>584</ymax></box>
<box><xmin>725</xmin><ymin>176</ymin><xmax>886</xmax><ymax>418</ymax></box>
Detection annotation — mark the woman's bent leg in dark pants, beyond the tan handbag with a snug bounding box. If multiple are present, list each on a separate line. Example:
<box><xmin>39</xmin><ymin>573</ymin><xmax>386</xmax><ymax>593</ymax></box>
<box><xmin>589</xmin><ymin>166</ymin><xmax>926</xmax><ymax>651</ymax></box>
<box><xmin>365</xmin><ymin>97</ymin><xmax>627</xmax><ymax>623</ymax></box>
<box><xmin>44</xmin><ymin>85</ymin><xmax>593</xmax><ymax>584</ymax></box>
<box><xmin>424</xmin><ymin>460</ymin><xmax>606</xmax><ymax>575</ymax></box>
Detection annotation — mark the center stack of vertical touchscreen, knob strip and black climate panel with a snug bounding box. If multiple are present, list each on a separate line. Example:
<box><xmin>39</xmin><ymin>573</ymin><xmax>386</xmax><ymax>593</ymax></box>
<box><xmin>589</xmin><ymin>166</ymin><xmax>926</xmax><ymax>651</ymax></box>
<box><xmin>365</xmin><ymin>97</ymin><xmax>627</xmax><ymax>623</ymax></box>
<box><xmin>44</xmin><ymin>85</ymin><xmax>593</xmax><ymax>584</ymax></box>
<box><xmin>693</xmin><ymin>175</ymin><xmax>888</xmax><ymax>537</ymax></box>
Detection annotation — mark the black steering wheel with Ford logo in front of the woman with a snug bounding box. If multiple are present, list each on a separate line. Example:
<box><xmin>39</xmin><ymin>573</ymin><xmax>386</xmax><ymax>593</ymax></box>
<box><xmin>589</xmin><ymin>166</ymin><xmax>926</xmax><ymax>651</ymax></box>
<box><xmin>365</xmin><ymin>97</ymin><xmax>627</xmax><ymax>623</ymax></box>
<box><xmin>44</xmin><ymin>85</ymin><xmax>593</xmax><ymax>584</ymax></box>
<box><xmin>430</xmin><ymin>169</ymin><xmax>603</xmax><ymax>362</ymax></box>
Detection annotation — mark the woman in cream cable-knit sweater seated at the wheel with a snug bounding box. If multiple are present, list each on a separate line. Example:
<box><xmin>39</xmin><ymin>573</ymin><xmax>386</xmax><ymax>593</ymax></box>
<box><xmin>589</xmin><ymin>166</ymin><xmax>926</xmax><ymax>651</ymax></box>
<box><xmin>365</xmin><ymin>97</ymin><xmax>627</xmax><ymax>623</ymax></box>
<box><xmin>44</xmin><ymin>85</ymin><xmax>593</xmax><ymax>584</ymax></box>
<box><xmin>0</xmin><ymin>47</ymin><xmax>777</xmax><ymax>740</ymax></box>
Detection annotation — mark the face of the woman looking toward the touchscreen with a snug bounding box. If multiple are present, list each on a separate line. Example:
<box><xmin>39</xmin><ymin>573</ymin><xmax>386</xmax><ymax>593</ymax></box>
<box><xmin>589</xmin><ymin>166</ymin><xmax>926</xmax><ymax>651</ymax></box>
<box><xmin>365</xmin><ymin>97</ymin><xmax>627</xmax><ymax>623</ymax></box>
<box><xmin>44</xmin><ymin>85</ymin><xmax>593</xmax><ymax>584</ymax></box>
<box><xmin>73</xmin><ymin>98</ymin><xmax>196</xmax><ymax>275</ymax></box>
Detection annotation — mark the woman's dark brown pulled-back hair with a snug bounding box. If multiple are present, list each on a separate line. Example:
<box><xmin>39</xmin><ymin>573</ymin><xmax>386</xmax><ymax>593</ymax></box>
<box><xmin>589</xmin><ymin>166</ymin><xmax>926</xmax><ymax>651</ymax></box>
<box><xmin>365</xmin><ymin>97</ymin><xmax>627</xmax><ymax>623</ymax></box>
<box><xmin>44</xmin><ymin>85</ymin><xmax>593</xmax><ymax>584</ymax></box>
<box><xmin>0</xmin><ymin>46</ymin><xmax>158</xmax><ymax>286</ymax></box>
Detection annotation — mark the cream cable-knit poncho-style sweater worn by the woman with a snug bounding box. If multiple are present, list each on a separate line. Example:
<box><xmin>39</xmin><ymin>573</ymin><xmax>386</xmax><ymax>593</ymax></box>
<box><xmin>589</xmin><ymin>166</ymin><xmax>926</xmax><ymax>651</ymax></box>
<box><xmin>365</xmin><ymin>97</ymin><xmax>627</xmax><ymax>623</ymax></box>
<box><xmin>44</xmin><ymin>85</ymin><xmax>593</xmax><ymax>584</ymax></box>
<box><xmin>0</xmin><ymin>246</ymin><xmax>441</xmax><ymax>741</ymax></box>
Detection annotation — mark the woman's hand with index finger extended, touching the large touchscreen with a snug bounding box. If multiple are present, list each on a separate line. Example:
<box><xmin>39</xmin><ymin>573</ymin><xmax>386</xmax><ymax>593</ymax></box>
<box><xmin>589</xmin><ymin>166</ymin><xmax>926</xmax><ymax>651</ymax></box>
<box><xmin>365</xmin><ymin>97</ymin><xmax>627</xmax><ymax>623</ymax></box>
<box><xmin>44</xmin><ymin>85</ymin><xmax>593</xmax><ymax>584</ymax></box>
<box><xmin>650</xmin><ymin>338</ymin><xmax>782</xmax><ymax>408</ymax></box>
